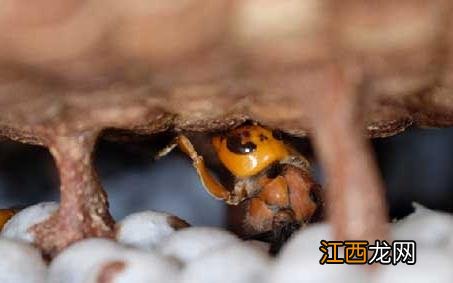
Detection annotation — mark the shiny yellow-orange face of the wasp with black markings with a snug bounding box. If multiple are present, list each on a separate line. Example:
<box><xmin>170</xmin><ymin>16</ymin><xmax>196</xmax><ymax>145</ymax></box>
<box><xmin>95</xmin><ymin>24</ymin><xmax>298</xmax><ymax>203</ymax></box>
<box><xmin>212</xmin><ymin>125</ymin><xmax>290</xmax><ymax>178</ymax></box>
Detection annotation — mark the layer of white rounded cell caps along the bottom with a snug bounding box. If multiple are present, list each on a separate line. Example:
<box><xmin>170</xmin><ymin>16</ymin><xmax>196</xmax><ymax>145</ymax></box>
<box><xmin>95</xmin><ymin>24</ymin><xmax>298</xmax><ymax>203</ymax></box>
<box><xmin>0</xmin><ymin>203</ymin><xmax>453</xmax><ymax>283</ymax></box>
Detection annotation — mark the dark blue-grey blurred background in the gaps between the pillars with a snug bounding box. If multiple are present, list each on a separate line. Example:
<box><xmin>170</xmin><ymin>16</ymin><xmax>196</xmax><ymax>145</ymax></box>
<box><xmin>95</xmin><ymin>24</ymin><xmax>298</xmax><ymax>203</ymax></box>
<box><xmin>0</xmin><ymin>128</ymin><xmax>453</xmax><ymax>229</ymax></box>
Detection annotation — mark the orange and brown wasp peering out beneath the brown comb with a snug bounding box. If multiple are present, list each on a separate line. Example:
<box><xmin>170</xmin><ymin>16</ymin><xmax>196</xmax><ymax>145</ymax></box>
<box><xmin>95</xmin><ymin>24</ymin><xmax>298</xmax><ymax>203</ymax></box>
<box><xmin>159</xmin><ymin>123</ymin><xmax>323</xmax><ymax>252</ymax></box>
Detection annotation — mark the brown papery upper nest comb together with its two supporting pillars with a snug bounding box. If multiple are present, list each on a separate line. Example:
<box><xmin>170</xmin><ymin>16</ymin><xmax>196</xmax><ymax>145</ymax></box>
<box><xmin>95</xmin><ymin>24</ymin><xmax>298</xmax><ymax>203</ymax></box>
<box><xmin>0</xmin><ymin>0</ymin><xmax>453</xmax><ymax>254</ymax></box>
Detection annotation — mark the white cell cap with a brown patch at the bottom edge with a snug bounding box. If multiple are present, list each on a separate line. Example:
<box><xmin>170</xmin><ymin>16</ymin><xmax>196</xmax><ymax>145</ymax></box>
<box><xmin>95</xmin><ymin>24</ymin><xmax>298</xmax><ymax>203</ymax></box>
<box><xmin>48</xmin><ymin>238</ymin><xmax>180</xmax><ymax>283</ymax></box>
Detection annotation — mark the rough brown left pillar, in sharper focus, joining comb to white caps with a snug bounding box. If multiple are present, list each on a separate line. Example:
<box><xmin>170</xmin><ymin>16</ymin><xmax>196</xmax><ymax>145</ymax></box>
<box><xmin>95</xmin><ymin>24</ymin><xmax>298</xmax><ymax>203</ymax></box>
<box><xmin>33</xmin><ymin>132</ymin><xmax>114</xmax><ymax>256</ymax></box>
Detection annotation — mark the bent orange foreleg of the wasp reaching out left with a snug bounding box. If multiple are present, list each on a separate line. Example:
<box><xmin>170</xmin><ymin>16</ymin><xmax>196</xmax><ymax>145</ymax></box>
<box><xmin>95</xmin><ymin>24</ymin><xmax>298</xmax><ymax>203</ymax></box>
<box><xmin>175</xmin><ymin>135</ymin><xmax>245</xmax><ymax>205</ymax></box>
